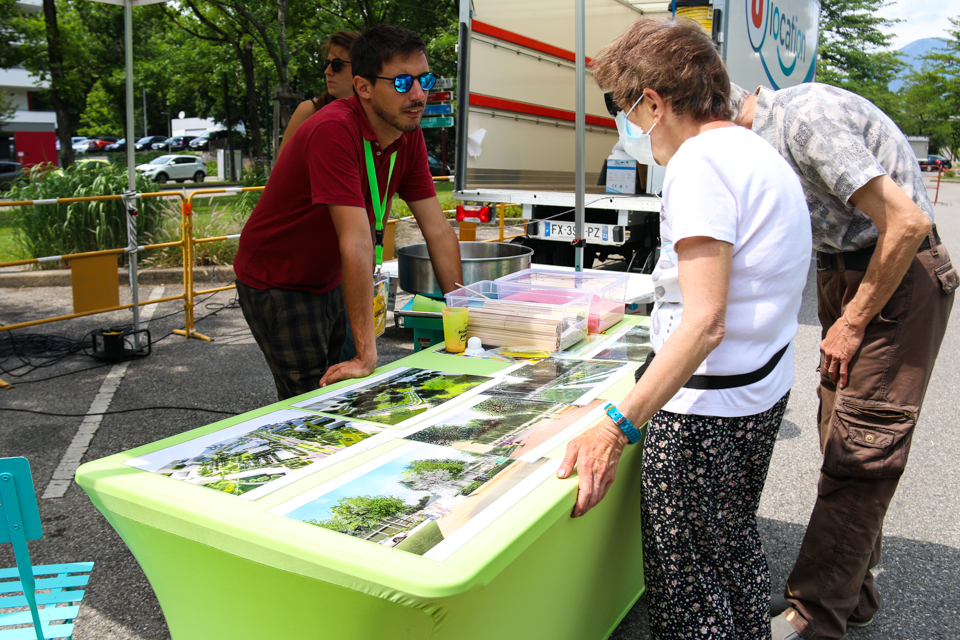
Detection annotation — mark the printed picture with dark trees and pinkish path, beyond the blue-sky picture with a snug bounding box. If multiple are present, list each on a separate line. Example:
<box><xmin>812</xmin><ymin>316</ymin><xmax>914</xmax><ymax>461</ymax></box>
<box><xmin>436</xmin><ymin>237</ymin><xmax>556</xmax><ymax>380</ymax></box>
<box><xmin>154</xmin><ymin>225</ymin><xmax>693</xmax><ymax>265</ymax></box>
<box><xmin>399</xmin><ymin>395</ymin><xmax>599</xmax><ymax>460</ymax></box>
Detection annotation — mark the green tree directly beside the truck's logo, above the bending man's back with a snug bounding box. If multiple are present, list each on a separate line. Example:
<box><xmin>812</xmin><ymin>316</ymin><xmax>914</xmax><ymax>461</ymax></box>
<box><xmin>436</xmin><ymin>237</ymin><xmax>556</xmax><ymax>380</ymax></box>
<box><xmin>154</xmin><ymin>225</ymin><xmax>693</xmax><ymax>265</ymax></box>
<box><xmin>817</xmin><ymin>0</ymin><xmax>904</xmax><ymax>114</ymax></box>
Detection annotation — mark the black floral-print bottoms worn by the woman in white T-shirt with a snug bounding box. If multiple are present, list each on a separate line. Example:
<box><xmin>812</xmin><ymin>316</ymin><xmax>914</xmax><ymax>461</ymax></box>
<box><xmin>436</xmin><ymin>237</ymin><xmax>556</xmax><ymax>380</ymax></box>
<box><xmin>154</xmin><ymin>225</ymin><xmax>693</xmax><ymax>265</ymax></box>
<box><xmin>641</xmin><ymin>392</ymin><xmax>790</xmax><ymax>640</ymax></box>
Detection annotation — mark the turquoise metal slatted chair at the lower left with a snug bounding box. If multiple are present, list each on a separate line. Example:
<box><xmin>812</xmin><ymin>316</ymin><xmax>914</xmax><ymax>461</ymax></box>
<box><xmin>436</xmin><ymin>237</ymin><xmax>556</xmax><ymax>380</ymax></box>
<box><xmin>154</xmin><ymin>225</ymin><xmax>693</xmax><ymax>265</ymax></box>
<box><xmin>0</xmin><ymin>458</ymin><xmax>93</xmax><ymax>640</ymax></box>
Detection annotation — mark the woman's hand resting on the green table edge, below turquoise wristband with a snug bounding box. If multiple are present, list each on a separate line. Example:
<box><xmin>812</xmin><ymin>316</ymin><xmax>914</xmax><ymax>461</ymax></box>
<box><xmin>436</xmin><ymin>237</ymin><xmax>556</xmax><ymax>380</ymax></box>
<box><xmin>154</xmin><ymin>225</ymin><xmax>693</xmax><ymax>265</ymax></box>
<box><xmin>557</xmin><ymin>418</ymin><xmax>630</xmax><ymax>518</ymax></box>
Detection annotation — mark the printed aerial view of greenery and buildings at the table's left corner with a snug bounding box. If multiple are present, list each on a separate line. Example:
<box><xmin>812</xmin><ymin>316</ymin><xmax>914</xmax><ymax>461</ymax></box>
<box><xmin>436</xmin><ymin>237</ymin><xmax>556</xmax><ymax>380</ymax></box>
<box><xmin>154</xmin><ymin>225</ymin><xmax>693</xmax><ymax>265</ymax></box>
<box><xmin>126</xmin><ymin>410</ymin><xmax>390</xmax><ymax>500</ymax></box>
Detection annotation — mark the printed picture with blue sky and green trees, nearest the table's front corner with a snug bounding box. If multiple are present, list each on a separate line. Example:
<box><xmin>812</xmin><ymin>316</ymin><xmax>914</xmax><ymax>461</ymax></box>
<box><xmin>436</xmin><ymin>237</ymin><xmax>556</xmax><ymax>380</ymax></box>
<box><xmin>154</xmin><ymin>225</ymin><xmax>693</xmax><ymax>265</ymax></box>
<box><xmin>271</xmin><ymin>442</ymin><xmax>555</xmax><ymax>559</ymax></box>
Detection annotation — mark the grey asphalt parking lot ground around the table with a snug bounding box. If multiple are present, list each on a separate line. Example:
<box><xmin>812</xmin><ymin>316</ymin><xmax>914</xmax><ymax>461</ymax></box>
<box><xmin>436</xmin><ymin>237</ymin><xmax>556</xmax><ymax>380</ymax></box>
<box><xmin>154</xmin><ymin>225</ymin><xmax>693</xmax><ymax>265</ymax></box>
<box><xmin>0</xmin><ymin>178</ymin><xmax>960</xmax><ymax>640</ymax></box>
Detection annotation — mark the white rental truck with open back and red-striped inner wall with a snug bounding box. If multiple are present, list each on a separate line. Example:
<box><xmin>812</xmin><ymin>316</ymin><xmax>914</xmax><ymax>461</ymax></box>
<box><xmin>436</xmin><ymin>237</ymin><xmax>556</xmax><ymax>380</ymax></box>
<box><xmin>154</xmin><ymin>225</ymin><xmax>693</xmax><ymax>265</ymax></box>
<box><xmin>454</xmin><ymin>0</ymin><xmax>820</xmax><ymax>272</ymax></box>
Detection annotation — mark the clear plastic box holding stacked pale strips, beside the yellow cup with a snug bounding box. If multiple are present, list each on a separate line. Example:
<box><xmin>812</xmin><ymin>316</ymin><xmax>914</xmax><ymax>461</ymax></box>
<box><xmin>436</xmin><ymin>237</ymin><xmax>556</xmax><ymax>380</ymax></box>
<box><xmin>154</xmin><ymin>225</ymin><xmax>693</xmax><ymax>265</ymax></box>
<box><xmin>446</xmin><ymin>280</ymin><xmax>592</xmax><ymax>352</ymax></box>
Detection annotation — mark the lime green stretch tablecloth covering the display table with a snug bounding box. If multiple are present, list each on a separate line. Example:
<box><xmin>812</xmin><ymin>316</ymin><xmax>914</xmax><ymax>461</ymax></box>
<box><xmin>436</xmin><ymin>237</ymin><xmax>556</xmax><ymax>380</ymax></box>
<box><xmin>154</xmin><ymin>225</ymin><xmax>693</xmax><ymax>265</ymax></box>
<box><xmin>77</xmin><ymin>319</ymin><xmax>644</xmax><ymax>640</ymax></box>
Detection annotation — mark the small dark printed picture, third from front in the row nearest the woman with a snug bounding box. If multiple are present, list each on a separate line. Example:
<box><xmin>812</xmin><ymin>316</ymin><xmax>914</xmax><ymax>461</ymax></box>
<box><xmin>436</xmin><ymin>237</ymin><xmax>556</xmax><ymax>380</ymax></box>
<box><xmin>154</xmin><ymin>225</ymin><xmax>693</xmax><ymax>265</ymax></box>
<box><xmin>486</xmin><ymin>358</ymin><xmax>632</xmax><ymax>405</ymax></box>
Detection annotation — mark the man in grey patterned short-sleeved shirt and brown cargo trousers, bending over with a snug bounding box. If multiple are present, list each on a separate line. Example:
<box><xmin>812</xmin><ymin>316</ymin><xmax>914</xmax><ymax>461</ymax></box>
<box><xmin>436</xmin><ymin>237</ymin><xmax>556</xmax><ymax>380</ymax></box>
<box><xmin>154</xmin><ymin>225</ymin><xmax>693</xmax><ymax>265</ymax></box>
<box><xmin>731</xmin><ymin>84</ymin><xmax>958</xmax><ymax>640</ymax></box>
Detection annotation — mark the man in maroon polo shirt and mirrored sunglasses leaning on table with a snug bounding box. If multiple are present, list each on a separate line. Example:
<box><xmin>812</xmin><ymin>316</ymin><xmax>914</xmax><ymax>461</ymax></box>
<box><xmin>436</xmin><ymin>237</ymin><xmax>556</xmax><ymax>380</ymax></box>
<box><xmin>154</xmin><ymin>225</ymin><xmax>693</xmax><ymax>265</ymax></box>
<box><xmin>234</xmin><ymin>25</ymin><xmax>462</xmax><ymax>399</ymax></box>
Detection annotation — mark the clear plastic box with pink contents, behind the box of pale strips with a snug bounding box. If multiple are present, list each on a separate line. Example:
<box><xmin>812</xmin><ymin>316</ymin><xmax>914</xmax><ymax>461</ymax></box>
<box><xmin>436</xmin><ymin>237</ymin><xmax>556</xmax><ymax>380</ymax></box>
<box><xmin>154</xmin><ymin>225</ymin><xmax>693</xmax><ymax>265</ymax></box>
<box><xmin>494</xmin><ymin>268</ymin><xmax>630</xmax><ymax>333</ymax></box>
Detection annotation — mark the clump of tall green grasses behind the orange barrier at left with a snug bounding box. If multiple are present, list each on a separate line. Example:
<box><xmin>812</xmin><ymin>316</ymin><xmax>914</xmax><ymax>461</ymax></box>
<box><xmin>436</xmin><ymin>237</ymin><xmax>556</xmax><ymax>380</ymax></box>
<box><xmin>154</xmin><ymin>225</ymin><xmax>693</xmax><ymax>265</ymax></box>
<box><xmin>7</xmin><ymin>163</ymin><xmax>172</xmax><ymax>268</ymax></box>
